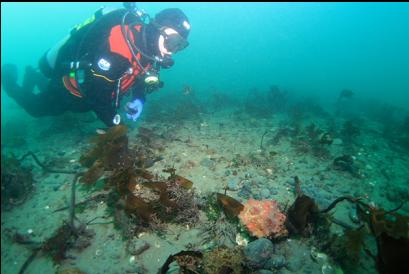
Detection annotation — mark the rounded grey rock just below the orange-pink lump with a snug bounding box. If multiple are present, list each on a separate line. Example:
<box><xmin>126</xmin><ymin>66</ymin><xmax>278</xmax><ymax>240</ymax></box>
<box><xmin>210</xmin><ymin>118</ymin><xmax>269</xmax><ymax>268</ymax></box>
<box><xmin>244</xmin><ymin>238</ymin><xmax>274</xmax><ymax>268</ymax></box>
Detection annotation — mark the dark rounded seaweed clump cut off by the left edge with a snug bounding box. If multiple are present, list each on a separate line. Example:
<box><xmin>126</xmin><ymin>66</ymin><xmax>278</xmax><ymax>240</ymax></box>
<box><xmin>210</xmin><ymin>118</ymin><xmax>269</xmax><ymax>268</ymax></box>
<box><xmin>1</xmin><ymin>154</ymin><xmax>34</xmax><ymax>210</ymax></box>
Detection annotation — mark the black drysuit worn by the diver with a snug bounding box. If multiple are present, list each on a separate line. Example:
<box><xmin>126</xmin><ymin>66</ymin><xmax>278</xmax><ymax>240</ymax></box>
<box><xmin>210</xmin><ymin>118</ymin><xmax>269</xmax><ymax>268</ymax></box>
<box><xmin>2</xmin><ymin>9</ymin><xmax>158</xmax><ymax>126</ymax></box>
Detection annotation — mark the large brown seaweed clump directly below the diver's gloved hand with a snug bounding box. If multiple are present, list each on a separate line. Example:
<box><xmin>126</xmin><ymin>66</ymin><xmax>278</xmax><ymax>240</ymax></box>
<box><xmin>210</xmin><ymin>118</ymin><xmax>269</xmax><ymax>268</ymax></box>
<box><xmin>80</xmin><ymin>125</ymin><xmax>198</xmax><ymax>236</ymax></box>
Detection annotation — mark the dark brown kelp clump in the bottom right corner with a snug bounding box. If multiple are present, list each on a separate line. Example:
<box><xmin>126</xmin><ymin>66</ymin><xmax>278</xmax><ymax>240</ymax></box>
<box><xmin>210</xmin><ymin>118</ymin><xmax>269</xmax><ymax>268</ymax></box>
<box><xmin>321</xmin><ymin>197</ymin><xmax>409</xmax><ymax>274</ymax></box>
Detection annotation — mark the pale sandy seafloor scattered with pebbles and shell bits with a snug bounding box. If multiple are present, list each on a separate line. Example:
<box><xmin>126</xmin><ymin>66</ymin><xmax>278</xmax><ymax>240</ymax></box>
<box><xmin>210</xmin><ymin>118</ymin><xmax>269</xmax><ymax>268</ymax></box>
<box><xmin>1</xmin><ymin>103</ymin><xmax>409</xmax><ymax>274</ymax></box>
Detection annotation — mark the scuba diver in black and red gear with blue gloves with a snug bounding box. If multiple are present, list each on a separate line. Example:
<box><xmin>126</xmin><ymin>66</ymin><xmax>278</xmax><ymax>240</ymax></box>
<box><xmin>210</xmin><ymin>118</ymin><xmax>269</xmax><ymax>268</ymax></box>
<box><xmin>1</xmin><ymin>2</ymin><xmax>190</xmax><ymax>127</ymax></box>
